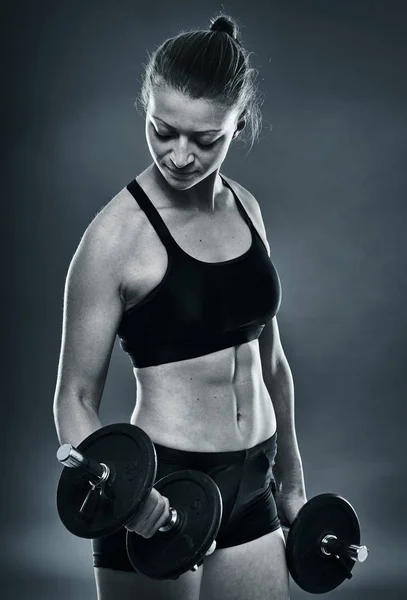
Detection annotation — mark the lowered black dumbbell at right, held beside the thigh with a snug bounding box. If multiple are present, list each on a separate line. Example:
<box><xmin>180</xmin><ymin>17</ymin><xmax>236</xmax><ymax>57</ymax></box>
<box><xmin>282</xmin><ymin>494</ymin><xmax>369</xmax><ymax>594</ymax></box>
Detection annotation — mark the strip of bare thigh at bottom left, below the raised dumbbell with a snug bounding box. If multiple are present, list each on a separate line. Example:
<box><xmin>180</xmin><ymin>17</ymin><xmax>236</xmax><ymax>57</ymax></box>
<box><xmin>94</xmin><ymin>567</ymin><xmax>203</xmax><ymax>600</ymax></box>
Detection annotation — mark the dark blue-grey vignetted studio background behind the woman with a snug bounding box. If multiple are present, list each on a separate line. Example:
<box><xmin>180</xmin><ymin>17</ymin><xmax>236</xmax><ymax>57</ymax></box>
<box><xmin>1</xmin><ymin>0</ymin><xmax>407</xmax><ymax>600</ymax></box>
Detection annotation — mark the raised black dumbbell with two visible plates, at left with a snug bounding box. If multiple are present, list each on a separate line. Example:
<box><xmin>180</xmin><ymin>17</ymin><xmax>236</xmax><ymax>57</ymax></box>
<box><xmin>57</xmin><ymin>423</ymin><xmax>222</xmax><ymax>579</ymax></box>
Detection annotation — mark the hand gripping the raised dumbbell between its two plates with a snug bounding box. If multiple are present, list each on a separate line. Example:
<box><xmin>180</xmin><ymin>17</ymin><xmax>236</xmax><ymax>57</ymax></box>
<box><xmin>125</xmin><ymin>488</ymin><xmax>170</xmax><ymax>538</ymax></box>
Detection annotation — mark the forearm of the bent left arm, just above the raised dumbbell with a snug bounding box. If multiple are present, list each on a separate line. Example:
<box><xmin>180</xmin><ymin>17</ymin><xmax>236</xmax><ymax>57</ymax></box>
<box><xmin>54</xmin><ymin>398</ymin><xmax>102</xmax><ymax>447</ymax></box>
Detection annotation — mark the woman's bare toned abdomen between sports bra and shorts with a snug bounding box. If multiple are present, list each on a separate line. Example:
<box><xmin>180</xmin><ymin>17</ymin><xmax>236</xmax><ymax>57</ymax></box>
<box><xmin>131</xmin><ymin>340</ymin><xmax>276</xmax><ymax>452</ymax></box>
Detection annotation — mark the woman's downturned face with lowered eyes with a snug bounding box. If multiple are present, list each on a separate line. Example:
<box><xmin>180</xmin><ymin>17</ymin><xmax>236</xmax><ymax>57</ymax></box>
<box><xmin>146</xmin><ymin>88</ymin><xmax>238</xmax><ymax>189</ymax></box>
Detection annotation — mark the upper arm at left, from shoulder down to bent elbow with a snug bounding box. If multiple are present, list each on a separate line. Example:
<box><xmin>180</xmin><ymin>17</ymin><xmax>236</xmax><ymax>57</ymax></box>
<box><xmin>55</xmin><ymin>219</ymin><xmax>123</xmax><ymax>409</ymax></box>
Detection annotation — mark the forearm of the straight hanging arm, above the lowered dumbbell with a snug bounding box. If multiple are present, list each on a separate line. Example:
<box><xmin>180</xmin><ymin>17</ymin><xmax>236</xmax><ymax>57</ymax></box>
<box><xmin>266</xmin><ymin>359</ymin><xmax>305</xmax><ymax>495</ymax></box>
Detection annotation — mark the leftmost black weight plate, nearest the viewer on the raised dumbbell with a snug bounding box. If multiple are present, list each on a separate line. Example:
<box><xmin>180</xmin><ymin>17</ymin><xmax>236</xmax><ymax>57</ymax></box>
<box><xmin>57</xmin><ymin>423</ymin><xmax>157</xmax><ymax>539</ymax></box>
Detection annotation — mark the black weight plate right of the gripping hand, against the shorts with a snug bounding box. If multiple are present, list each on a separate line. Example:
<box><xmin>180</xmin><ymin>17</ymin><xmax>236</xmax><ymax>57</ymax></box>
<box><xmin>127</xmin><ymin>469</ymin><xmax>222</xmax><ymax>579</ymax></box>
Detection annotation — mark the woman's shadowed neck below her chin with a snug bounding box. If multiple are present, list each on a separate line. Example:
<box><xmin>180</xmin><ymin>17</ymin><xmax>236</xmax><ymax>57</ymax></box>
<box><xmin>149</xmin><ymin>163</ymin><xmax>224</xmax><ymax>213</ymax></box>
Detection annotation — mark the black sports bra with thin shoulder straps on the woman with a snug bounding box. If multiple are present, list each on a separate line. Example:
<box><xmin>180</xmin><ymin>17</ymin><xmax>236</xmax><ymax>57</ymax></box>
<box><xmin>117</xmin><ymin>177</ymin><xmax>281</xmax><ymax>368</ymax></box>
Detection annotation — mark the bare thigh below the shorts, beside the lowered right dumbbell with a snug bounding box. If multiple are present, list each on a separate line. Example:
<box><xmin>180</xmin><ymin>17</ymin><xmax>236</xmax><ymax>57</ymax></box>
<box><xmin>200</xmin><ymin>528</ymin><xmax>290</xmax><ymax>600</ymax></box>
